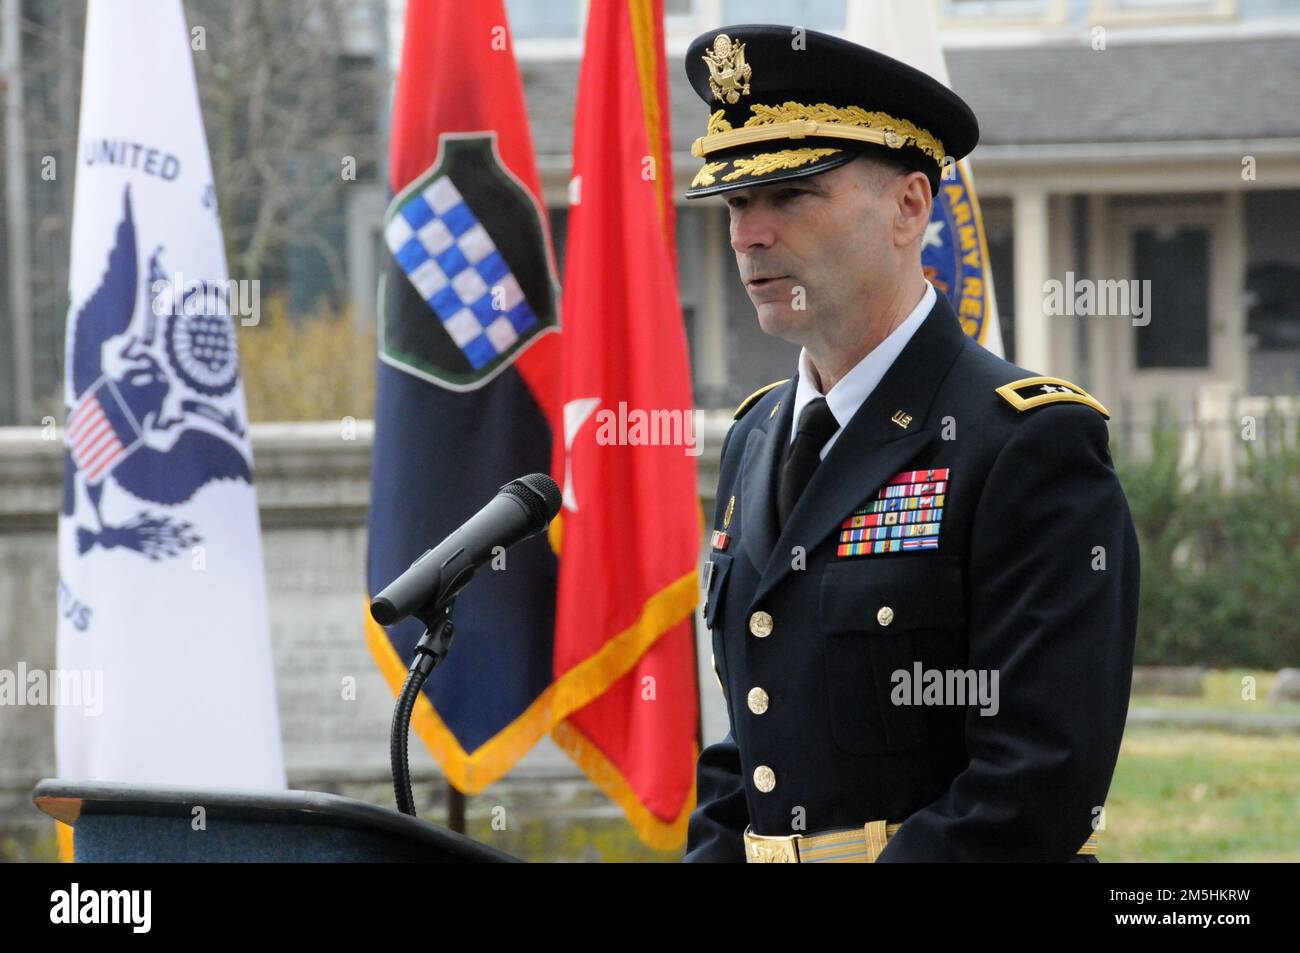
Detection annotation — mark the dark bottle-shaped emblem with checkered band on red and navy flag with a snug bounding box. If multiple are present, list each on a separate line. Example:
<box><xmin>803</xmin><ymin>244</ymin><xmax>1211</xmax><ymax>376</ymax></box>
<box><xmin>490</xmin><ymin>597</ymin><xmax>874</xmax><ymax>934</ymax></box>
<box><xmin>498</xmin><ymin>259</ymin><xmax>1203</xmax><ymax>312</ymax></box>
<box><xmin>380</xmin><ymin>133</ymin><xmax>558</xmax><ymax>390</ymax></box>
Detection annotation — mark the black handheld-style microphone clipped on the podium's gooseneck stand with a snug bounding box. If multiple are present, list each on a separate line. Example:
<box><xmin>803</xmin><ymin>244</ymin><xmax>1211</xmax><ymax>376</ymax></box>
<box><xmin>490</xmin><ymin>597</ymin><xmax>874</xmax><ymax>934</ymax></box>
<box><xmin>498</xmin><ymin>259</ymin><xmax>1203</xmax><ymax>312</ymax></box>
<box><xmin>371</xmin><ymin>473</ymin><xmax>560</xmax><ymax>625</ymax></box>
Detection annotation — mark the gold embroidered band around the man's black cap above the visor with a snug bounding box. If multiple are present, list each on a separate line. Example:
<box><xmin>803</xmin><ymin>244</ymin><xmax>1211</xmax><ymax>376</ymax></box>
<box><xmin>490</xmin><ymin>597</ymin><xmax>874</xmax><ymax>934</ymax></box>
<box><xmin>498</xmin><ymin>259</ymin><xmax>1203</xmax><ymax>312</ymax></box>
<box><xmin>690</xmin><ymin>103</ymin><xmax>944</xmax><ymax>169</ymax></box>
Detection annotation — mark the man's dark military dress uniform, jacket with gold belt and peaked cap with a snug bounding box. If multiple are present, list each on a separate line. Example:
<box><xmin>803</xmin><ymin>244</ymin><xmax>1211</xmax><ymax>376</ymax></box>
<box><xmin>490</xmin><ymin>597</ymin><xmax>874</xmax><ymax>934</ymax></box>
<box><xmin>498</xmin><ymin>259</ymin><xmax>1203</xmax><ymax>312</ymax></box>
<box><xmin>685</xmin><ymin>27</ymin><xmax>1139</xmax><ymax>862</ymax></box>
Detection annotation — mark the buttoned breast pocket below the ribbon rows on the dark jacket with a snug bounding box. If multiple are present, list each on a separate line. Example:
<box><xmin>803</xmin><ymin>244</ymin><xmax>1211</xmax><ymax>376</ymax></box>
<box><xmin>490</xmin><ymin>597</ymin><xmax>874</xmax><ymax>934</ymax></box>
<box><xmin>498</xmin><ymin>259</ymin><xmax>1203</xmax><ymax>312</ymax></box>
<box><xmin>819</xmin><ymin>555</ymin><xmax>966</xmax><ymax>754</ymax></box>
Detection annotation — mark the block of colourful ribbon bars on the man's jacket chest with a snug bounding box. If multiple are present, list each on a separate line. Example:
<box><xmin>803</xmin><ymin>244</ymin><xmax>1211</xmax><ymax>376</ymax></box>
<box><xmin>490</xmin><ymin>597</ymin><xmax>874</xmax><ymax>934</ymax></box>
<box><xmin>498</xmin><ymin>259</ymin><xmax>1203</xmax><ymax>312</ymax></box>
<box><xmin>835</xmin><ymin>467</ymin><xmax>949</xmax><ymax>556</ymax></box>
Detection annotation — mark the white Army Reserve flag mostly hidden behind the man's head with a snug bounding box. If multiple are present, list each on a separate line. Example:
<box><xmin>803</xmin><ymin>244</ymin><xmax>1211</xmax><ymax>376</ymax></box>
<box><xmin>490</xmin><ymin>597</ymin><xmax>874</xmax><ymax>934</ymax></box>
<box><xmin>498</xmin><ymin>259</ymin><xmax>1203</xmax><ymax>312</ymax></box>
<box><xmin>844</xmin><ymin>0</ymin><xmax>1004</xmax><ymax>358</ymax></box>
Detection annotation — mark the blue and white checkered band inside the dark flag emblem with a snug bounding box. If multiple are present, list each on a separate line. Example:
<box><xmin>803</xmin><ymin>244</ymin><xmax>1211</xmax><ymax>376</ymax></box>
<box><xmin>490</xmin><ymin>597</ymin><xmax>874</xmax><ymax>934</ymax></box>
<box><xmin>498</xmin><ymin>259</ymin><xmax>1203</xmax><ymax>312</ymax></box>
<box><xmin>384</xmin><ymin>176</ymin><xmax>538</xmax><ymax>371</ymax></box>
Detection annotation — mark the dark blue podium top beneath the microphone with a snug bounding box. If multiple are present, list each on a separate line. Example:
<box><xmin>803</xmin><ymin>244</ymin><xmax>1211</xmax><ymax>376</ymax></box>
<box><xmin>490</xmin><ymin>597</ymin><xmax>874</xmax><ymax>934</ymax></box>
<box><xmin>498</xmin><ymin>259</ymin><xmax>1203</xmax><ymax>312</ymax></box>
<box><xmin>31</xmin><ymin>779</ymin><xmax>521</xmax><ymax>863</ymax></box>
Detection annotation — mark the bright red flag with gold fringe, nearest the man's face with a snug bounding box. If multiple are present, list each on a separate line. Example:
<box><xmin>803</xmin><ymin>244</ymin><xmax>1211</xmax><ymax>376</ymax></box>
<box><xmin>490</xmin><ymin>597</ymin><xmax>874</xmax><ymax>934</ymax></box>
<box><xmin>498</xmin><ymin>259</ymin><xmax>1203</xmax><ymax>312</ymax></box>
<box><xmin>551</xmin><ymin>0</ymin><xmax>701</xmax><ymax>850</ymax></box>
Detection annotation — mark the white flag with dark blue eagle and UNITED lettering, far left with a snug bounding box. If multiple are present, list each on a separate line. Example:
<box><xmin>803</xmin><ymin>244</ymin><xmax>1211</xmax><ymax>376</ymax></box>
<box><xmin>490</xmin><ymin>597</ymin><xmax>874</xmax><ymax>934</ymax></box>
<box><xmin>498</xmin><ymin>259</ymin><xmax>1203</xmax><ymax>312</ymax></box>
<box><xmin>56</xmin><ymin>0</ymin><xmax>285</xmax><ymax>788</ymax></box>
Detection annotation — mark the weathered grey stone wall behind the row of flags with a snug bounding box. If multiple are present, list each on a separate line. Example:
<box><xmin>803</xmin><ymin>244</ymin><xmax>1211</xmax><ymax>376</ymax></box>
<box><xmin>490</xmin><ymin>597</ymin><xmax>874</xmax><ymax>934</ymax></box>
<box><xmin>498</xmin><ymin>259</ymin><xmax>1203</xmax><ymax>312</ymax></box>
<box><xmin>0</xmin><ymin>415</ymin><xmax>729</xmax><ymax>853</ymax></box>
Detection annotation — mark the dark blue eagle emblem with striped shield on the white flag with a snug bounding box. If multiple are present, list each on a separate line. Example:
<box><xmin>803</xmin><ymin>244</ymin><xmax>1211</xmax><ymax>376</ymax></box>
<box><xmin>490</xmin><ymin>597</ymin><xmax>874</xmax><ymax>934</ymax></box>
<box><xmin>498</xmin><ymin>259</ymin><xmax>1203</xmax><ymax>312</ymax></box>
<box><xmin>62</xmin><ymin>187</ymin><xmax>252</xmax><ymax>560</ymax></box>
